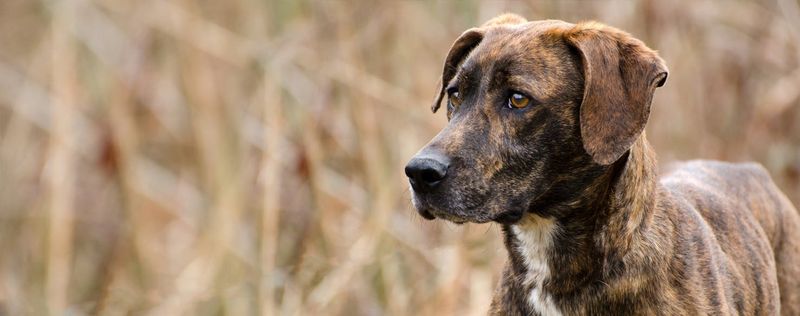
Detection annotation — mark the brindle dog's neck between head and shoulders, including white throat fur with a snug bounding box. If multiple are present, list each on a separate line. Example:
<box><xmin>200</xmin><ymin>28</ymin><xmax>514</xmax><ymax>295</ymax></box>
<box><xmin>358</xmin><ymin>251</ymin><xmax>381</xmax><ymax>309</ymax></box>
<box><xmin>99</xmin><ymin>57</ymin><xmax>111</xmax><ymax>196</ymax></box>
<box><xmin>503</xmin><ymin>134</ymin><xmax>658</xmax><ymax>304</ymax></box>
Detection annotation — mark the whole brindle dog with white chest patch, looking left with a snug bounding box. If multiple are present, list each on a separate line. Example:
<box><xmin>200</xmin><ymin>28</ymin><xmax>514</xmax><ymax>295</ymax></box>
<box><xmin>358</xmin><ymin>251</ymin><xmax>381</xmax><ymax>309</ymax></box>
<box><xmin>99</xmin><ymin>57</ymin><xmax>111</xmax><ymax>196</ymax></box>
<box><xmin>405</xmin><ymin>14</ymin><xmax>800</xmax><ymax>315</ymax></box>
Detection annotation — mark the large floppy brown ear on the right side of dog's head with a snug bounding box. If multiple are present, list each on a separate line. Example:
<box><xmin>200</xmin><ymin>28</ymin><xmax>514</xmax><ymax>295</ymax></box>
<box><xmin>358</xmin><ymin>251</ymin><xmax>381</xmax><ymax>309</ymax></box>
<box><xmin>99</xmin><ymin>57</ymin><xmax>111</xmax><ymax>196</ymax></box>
<box><xmin>565</xmin><ymin>22</ymin><xmax>667</xmax><ymax>165</ymax></box>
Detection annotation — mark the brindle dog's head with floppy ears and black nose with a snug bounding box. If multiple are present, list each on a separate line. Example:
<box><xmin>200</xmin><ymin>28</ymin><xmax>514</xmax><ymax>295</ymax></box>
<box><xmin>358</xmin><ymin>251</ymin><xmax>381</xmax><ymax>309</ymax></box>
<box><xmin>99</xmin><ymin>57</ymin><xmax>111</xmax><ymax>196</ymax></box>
<box><xmin>405</xmin><ymin>15</ymin><xmax>667</xmax><ymax>223</ymax></box>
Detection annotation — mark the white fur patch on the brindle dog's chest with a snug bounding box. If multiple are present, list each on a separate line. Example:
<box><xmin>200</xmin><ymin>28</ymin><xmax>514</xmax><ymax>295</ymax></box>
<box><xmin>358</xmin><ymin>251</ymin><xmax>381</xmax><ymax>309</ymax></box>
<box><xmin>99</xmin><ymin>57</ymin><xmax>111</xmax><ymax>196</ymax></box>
<box><xmin>511</xmin><ymin>214</ymin><xmax>561</xmax><ymax>316</ymax></box>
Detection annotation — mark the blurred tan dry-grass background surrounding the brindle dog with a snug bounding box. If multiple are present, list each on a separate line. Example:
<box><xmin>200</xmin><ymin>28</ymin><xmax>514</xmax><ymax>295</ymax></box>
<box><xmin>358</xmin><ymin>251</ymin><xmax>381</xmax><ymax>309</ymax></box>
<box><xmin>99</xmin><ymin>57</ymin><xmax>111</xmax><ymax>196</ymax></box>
<box><xmin>0</xmin><ymin>0</ymin><xmax>800</xmax><ymax>315</ymax></box>
